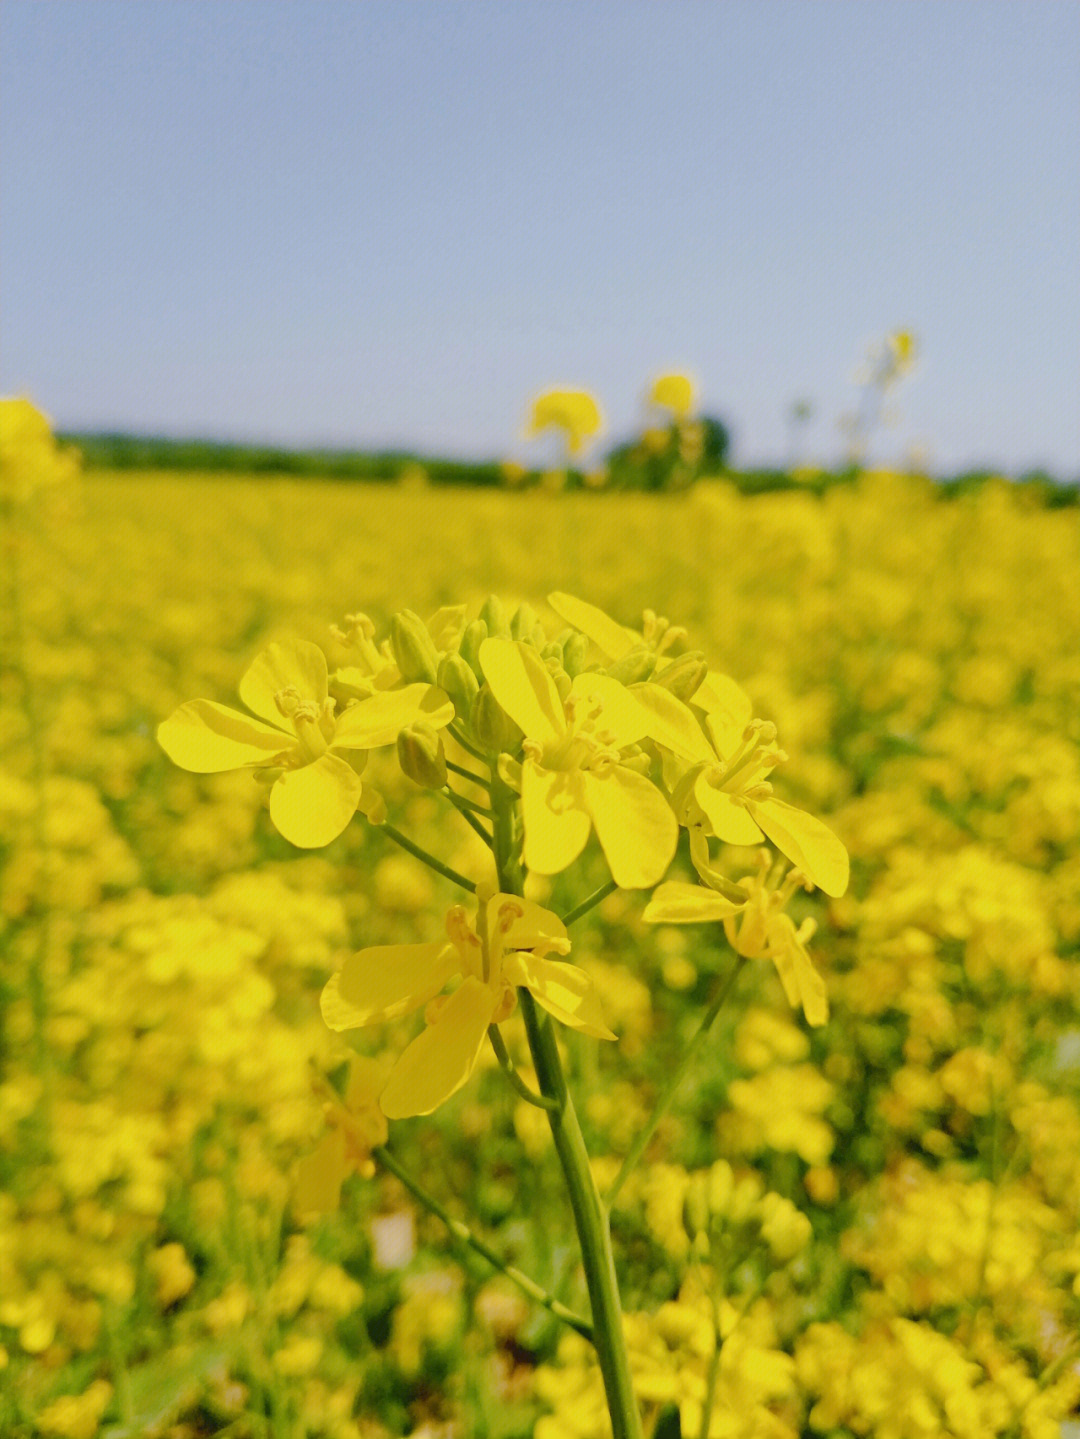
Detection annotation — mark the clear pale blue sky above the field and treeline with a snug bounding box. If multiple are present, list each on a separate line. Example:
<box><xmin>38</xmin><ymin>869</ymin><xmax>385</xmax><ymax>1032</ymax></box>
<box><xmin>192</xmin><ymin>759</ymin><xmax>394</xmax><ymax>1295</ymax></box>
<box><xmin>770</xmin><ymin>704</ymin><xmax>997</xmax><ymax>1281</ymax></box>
<box><xmin>0</xmin><ymin>0</ymin><xmax>1080</xmax><ymax>476</ymax></box>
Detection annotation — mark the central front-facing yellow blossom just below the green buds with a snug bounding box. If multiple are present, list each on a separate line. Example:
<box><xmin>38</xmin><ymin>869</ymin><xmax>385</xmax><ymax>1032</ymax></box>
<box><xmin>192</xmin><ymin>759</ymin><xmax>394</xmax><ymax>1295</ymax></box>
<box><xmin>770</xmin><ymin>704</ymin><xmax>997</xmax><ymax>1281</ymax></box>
<box><xmin>480</xmin><ymin>639</ymin><xmax>679</xmax><ymax>889</ymax></box>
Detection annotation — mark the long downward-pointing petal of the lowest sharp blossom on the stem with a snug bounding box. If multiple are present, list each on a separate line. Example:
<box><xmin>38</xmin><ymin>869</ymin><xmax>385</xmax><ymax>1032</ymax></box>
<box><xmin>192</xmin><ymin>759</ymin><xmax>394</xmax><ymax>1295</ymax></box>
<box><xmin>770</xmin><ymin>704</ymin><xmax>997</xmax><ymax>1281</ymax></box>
<box><xmin>380</xmin><ymin>976</ymin><xmax>495</xmax><ymax>1120</ymax></box>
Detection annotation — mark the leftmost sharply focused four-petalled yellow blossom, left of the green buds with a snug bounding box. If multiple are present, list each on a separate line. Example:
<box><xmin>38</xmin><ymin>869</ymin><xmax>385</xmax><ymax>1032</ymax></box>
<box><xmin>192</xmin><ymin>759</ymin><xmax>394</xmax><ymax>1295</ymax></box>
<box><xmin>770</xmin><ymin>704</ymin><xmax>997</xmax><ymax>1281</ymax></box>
<box><xmin>158</xmin><ymin>640</ymin><xmax>453</xmax><ymax>849</ymax></box>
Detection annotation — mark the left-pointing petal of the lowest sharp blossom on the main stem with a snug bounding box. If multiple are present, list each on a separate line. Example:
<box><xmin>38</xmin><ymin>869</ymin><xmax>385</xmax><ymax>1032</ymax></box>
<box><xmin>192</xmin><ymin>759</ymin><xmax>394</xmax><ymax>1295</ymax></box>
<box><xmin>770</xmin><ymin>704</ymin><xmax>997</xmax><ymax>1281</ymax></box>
<box><xmin>321</xmin><ymin>941</ymin><xmax>462</xmax><ymax>1030</ymax></box>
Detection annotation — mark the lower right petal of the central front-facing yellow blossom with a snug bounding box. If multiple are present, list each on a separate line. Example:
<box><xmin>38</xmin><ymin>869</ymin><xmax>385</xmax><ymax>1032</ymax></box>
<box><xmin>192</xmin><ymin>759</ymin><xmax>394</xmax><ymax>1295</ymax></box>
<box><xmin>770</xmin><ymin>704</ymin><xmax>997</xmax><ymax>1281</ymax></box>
<box><xmin>582</xmin><ymin>764</ymin><xmax>679</xmax><ymax>889</ymax></box>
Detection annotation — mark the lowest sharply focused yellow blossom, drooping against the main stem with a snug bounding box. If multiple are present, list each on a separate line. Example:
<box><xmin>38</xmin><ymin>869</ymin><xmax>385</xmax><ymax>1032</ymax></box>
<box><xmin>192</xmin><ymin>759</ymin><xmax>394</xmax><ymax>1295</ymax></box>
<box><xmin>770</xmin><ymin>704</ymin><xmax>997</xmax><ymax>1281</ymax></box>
<box><xmin>322</xmin><ymin>894</ymin><xmax>615</xmax><ymax>1120</ymax></box>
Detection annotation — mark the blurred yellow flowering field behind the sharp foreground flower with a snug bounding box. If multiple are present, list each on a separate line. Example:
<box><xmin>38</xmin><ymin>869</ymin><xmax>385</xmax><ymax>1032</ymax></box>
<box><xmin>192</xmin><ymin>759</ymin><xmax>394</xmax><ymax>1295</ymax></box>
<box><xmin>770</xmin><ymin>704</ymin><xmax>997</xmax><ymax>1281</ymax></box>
<box><xmin>0</xmin><ymin>417</ymin><xmax>1080</xmax><ymax>1439</ymax></box>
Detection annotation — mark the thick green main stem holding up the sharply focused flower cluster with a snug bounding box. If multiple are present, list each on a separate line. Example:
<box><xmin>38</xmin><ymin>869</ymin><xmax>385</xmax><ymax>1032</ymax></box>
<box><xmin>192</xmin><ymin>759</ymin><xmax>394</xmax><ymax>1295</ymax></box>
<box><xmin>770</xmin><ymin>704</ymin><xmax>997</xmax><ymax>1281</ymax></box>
<box><xmin>492</xmin><ymin>776</ymin><xmax>641</xmax><ymax>1439</ymax></box>
